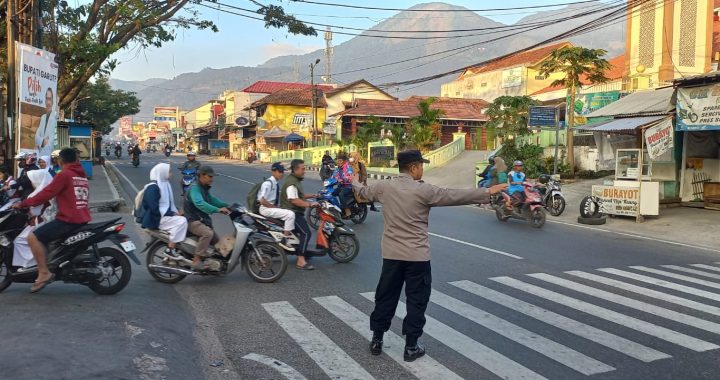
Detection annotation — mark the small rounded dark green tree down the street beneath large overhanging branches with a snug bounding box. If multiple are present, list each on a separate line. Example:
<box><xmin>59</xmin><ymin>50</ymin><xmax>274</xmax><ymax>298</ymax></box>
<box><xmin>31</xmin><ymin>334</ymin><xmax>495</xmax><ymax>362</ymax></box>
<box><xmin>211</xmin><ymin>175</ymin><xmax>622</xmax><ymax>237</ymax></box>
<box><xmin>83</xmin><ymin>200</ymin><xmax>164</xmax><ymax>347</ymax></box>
<box><xmin>71</xmin><ymin>77</ymin><xmax>140</xmax><ymax>135</ymax></box>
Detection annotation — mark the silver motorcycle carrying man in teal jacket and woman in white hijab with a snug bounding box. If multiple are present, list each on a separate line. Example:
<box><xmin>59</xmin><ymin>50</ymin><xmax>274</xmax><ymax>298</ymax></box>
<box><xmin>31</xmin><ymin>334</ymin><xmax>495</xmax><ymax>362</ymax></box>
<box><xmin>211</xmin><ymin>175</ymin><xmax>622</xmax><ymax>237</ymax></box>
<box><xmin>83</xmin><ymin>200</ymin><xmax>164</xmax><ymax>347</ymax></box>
<box><xmin>143</xmin><ymin>205</ymin><xmax>288</xmax><ymax>284</ymax></box>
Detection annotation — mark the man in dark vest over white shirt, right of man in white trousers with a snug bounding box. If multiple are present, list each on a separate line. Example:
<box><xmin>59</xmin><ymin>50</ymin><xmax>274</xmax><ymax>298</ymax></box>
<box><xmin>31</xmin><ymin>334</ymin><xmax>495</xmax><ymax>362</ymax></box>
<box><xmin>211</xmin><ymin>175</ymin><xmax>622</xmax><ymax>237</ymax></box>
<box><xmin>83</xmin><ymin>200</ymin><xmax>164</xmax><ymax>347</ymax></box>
<box><xmin>280</xmin><ymin>159</ymin><xmax>318</xmax><ymax>270</ymax></box>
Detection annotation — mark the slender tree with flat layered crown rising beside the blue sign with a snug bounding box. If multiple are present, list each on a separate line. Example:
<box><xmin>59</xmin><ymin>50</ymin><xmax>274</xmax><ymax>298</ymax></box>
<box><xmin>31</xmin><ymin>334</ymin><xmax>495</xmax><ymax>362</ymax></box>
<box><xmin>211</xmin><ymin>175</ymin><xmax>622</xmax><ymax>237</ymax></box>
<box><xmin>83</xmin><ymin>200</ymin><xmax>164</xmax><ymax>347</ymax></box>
<box><xmin>539</xmin><ymin>46</ymin><xmax>612</xmax><ymax>175</ymax></box>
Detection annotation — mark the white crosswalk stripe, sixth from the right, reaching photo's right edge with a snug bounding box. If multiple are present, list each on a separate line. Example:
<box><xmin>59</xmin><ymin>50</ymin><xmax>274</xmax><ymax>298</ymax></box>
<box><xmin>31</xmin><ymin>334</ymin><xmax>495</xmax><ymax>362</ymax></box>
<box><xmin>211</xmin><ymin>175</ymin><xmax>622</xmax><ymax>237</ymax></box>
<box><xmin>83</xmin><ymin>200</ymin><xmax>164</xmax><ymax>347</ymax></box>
<box><xmin>528</xmin><ymin>273</ymin><xmax>720</xmax><ymax>335</ymax></box>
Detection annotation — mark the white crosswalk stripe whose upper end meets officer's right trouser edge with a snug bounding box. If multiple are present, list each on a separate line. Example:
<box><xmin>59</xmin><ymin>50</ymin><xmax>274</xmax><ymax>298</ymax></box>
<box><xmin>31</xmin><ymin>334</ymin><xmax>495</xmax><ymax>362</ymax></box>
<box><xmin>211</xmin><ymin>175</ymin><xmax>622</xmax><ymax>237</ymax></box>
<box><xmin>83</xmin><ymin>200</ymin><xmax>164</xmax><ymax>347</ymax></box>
<box><xmin>430</xmin><ymin>290</ymin><xmax>615</xmax><ymax>376</ymax></box>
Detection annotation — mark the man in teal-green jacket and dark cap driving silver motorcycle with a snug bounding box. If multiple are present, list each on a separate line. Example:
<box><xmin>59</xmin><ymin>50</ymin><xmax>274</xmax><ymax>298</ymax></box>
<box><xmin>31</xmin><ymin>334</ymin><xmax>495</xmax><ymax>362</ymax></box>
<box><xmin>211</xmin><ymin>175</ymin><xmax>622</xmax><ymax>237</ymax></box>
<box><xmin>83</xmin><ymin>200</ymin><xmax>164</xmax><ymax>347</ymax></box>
<box><xmin>183</xmin><ymin>165</ymin><xmax>230</xmax><ymax>270</ymax></box>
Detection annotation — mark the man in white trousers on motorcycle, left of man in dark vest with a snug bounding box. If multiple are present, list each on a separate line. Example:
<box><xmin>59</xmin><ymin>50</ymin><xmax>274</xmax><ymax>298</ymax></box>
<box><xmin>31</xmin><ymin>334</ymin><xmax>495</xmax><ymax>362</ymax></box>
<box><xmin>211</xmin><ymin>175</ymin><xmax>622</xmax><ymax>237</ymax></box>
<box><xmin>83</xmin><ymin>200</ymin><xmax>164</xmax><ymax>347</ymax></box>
<box><xmin>257</xmin><ymin>162</ymin><xmax>295</xmax><ymax>252</ymax></box>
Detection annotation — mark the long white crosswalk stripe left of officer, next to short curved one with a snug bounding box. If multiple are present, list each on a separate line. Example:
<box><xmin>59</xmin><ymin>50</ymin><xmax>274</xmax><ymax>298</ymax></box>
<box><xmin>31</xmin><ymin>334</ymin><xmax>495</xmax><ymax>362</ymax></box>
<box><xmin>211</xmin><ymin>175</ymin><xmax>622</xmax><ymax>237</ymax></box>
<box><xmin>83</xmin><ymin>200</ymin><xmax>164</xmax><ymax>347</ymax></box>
<box><xmin>262</xmin><ymin>301</ymin><xmax>373</xmax><ymax>379</ymax></box>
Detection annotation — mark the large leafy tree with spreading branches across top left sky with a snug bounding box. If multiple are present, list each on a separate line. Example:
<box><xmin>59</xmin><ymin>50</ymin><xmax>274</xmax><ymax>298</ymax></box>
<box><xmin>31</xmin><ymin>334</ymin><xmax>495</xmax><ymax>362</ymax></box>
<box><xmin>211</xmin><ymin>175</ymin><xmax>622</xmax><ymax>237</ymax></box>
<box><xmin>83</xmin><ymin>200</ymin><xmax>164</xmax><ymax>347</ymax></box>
<box><xmin>0</xmin><ymin>0</ymin><xmax>317</xmax><ymax>109</ymax></box>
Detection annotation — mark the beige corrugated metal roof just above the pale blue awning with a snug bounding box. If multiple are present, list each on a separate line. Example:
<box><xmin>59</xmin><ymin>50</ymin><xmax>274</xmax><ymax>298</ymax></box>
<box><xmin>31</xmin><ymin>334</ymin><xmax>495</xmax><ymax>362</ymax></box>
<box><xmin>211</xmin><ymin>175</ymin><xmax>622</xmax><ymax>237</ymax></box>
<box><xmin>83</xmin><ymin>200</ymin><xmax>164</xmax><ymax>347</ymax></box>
<box><xmin>587</xmin><ymin>87</ymin><xmax>675</xmax><ymax>117</ymax></box>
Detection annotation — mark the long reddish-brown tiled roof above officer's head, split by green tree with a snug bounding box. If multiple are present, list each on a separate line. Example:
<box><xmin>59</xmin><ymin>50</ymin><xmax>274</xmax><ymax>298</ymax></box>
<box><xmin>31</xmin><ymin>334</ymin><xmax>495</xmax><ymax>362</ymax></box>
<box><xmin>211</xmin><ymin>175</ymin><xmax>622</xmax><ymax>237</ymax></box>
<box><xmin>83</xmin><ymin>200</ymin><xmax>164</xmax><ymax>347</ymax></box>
<box><xmin>332</xmin><ymin>97</ymin><xmax>488</xmax><ymax>121</ymax></box>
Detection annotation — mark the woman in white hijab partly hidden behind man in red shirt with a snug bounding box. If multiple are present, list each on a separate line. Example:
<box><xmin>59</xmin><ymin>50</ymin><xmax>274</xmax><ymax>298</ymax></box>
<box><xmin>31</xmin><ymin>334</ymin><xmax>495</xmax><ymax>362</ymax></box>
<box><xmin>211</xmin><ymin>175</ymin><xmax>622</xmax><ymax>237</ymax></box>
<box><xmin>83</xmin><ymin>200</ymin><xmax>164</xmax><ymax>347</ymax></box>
<box><xmin>13</xmin><ymin>170</ymin><xmax>56</xmax><ymax>267</ymax></box>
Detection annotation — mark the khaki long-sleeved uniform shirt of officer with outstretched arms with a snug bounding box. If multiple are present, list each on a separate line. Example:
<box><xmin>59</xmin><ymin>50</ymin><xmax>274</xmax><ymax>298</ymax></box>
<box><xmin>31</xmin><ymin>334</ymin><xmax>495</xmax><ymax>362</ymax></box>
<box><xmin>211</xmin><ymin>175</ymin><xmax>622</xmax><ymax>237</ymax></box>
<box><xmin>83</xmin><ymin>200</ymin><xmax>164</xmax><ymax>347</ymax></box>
<box><xmin>353</xmin><ymin>173</ymin><xmax>490</xmax><ymax>261</ymax></box>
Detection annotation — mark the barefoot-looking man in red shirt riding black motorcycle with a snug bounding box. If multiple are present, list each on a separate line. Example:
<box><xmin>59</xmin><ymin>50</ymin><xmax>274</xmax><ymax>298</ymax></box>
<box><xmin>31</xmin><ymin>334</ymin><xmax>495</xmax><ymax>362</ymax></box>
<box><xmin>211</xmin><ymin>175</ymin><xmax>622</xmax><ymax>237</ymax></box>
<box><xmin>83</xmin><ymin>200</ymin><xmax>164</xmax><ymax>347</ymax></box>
<box><xmin>13</xmin><ymin>148</ymin><xmax>92</xmax><ymax>293</ymax></box>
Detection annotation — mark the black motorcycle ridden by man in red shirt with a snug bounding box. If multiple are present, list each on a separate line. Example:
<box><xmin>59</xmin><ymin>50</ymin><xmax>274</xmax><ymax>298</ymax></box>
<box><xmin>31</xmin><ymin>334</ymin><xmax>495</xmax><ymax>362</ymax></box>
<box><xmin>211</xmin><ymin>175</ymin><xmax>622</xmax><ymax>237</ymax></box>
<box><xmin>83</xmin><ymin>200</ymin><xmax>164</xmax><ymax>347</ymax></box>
<box><xmin>0</xmin><ymin>210</ymin><xmax>140</xmax><ymax>295</ymax></box>
